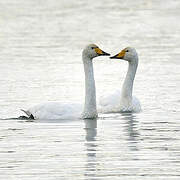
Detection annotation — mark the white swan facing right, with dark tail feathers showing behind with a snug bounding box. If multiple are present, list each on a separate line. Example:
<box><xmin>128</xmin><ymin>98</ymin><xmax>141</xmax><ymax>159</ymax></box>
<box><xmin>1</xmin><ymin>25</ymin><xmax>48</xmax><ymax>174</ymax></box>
<box><xmin>22</xmin><ymin>44</ymin><xmax>110</xmax><ymax>119</ymax></box>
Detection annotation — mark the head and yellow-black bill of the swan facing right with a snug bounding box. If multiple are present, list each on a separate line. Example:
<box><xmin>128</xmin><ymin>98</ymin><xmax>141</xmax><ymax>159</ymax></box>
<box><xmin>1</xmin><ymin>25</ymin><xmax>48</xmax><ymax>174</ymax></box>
<box><xmin>83</xmin><ymin>44</ymin><xmax>110</xmax><ymax>59</ymax></box>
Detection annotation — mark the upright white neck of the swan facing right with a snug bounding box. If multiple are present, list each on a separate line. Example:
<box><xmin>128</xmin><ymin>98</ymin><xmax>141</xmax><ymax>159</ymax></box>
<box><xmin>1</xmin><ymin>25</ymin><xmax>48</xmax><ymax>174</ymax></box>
<box><xmin>82</xmin><ymin>55</ymin><xmax>97</xmax><ymax>119</ymax></box>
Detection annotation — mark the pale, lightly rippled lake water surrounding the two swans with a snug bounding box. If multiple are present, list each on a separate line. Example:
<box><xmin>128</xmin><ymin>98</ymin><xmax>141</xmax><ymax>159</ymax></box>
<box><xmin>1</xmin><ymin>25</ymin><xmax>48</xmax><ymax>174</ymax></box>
<box><xmin>0</xmin><ymin>0</ymin><xmax>180</xmax><ymax>180</ymax></box>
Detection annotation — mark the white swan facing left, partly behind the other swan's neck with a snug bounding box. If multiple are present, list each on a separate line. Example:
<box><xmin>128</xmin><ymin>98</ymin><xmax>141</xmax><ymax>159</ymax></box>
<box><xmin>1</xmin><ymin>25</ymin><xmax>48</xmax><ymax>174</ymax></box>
<box><xmin>99</xmin><ymin>47</ymin><xmax>141</xmax><ymax>113</ymax></box>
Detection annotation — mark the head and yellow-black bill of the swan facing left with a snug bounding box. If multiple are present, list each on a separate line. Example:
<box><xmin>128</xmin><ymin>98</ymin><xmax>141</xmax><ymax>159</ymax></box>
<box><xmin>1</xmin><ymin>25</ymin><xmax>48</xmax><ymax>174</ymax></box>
<box><xmin>110</xmin><ymin>47</ymin><xmax>138</xmax><ymax>63</ymax></box>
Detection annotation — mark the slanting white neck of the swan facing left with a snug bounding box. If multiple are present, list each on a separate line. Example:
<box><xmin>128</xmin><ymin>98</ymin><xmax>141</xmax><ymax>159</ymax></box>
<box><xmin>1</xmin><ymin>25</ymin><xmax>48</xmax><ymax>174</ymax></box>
<box><xmin>121</xmin><ymin>59</ymin><xmax>138</xmax><ymax>103</ymax></box>
